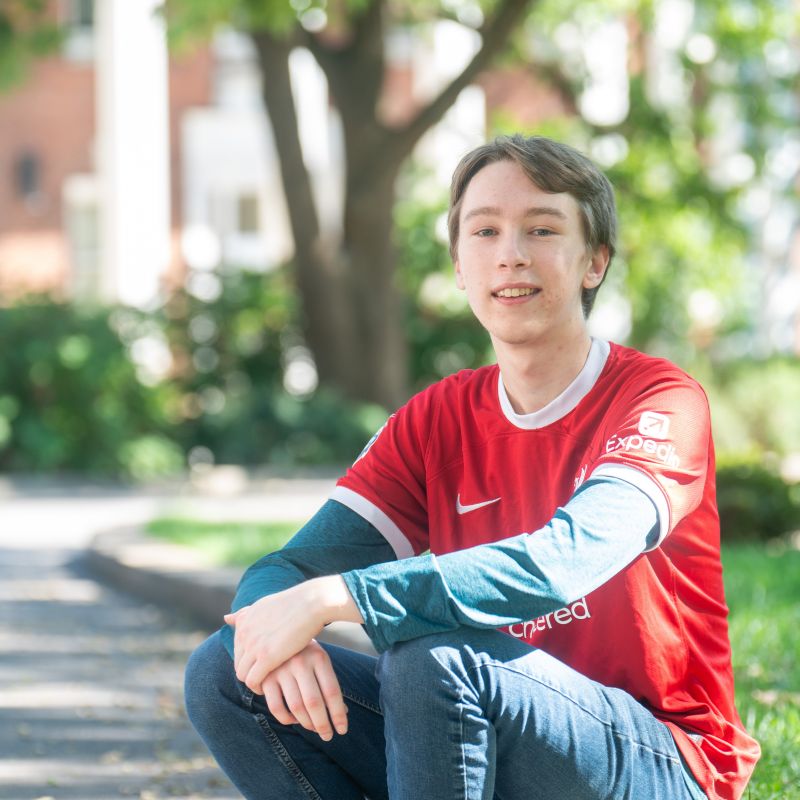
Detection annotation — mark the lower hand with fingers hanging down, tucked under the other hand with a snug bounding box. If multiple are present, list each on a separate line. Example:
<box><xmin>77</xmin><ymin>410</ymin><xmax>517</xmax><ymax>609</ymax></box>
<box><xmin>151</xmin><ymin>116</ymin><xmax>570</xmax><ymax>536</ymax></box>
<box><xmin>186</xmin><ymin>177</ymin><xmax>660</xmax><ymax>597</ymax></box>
<box><xmin>262</xmin><ymin>640</ymin><xmax>347</xmax><ymax>742</ymax></box>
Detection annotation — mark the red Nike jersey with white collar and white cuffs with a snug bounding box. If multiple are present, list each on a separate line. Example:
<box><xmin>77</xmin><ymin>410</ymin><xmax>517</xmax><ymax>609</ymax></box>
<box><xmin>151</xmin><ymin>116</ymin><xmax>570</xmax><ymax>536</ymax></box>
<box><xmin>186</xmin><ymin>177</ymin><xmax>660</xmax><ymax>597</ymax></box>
<box><xmin>332</xmin><ymin>340</ymin><xmax>760</xmax><ymax>800</ymax></box>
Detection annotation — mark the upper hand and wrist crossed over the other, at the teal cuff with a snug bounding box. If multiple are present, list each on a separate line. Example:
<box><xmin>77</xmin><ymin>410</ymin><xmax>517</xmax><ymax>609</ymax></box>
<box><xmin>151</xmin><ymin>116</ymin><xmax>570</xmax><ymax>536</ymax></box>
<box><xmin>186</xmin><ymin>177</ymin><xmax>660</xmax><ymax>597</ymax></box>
<box><xmin>225</xmin><ymin>575</ymin><xmax>363</xmax><ymax>693</ymax></box>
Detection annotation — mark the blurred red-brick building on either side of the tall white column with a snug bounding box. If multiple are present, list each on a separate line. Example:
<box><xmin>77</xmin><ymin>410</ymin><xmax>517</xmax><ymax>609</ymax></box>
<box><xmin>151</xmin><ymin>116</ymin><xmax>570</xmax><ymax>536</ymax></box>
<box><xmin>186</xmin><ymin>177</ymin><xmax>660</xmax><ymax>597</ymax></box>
<box><xmin>0</xmin><ymin>0</ymin><xmax>212</xmax><ymax>300</ymax></box>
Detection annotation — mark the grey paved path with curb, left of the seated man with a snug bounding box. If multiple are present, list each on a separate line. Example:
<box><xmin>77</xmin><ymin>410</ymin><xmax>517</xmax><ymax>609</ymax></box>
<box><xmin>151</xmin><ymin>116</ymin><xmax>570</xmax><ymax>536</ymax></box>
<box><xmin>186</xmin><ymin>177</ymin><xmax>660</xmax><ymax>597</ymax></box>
<box><xmin>0</xmin><ymin>473</ymin><xmax>366</xmax><ymax>800</ymax></box>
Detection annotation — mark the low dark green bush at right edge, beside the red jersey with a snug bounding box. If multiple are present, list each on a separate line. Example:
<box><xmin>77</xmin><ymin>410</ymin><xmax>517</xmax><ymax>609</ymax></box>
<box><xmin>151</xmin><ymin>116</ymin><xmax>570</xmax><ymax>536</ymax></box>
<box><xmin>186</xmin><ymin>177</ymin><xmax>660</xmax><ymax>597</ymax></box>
<box><xmin>717</xmin><ymin>456</ymin><xmax>800</xmax><ymax>541</ymax></box>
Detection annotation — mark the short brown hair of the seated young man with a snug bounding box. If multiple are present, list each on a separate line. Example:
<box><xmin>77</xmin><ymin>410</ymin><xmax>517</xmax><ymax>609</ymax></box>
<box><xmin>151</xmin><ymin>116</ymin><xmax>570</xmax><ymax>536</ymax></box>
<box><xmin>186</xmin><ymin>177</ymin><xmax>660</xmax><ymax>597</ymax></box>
<box><xmin>447</xmin><ymin>134</ymin><xmax>617</xmax><ymax>317</ymax></box>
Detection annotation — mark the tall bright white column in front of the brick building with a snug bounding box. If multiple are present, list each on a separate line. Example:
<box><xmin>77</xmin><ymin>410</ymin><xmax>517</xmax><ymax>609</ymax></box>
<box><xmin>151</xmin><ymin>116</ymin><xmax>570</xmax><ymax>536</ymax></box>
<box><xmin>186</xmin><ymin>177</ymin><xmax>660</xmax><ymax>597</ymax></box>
<box><xmin>96</xmin><ymin>0</ymin><xmax>170</xmax><ymax>306</ymax></box>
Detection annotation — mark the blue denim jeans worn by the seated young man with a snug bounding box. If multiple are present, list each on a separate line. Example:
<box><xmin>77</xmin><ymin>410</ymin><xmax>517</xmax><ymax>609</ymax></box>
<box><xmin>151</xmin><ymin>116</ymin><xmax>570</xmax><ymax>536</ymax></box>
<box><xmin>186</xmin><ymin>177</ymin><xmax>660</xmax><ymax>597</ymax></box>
<box><xmin>186</xmin><ymin>628</ymin><xmax>705</xmax><ymax>800</ymax></box>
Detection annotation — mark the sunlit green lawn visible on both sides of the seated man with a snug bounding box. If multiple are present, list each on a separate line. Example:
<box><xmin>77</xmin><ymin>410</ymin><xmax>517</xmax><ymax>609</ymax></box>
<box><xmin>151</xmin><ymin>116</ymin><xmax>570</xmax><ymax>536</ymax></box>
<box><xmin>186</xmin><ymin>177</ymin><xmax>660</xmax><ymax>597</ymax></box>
<box><xmin>149</xmin><ymin>519</ymin><xmax>800</xmax><ymax>800</ymax></box>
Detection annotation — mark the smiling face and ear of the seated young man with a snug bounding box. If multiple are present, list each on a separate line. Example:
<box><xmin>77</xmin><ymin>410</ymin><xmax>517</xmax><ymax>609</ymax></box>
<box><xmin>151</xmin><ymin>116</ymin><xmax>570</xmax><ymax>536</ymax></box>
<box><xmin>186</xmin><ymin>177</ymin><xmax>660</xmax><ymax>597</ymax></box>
<box><xmin>455</xmin><ymin>161</ymin><xmax>608</xmax><ymax>349</ymax></box>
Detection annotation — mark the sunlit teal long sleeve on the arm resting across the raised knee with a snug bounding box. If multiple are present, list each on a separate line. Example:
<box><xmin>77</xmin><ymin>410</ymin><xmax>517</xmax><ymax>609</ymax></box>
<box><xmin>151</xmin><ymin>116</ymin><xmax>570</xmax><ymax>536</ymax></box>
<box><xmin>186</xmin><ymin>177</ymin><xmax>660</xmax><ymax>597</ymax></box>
<box><xmin>343</xmin><ymin>479</ymin><xmax>657</xmax><ymax>650</ymax></box>
